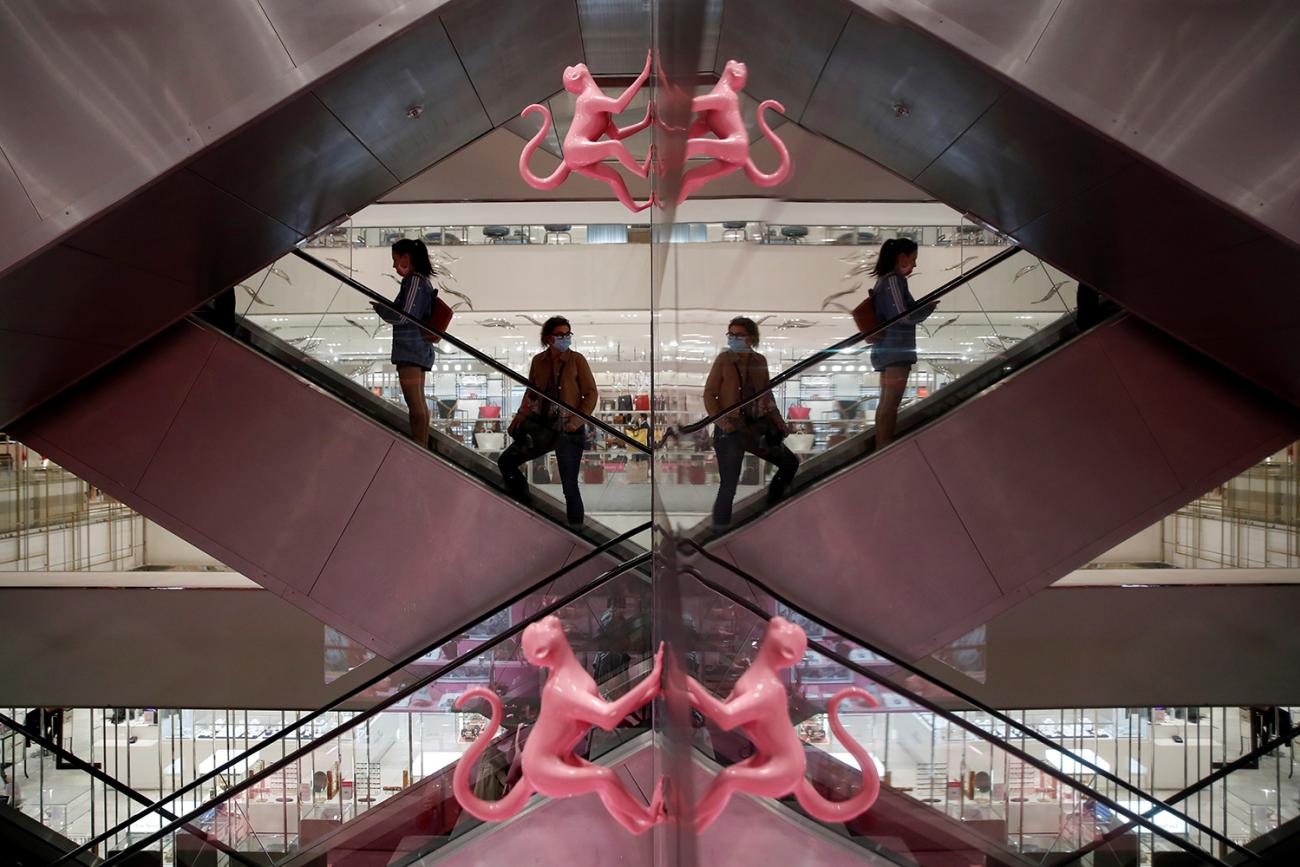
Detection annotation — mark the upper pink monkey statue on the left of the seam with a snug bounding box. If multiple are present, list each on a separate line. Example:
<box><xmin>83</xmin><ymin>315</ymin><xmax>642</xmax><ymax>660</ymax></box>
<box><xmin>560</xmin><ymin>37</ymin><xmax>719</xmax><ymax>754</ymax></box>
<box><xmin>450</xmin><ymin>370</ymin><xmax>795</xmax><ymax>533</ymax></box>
<box><xmin>519</xmin><ymin>53</ymin><xmax>654</xmax><ymax>213</ymax></box>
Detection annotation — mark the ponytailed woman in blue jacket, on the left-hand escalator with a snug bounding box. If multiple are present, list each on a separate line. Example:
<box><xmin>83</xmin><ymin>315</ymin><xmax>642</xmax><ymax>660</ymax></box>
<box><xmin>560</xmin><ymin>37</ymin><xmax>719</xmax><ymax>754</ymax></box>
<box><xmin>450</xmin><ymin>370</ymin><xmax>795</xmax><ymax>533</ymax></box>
<box><xmin>372</xmin><ymin>238</ymin><xmax>438</xmax><ymax>447</ymax></box>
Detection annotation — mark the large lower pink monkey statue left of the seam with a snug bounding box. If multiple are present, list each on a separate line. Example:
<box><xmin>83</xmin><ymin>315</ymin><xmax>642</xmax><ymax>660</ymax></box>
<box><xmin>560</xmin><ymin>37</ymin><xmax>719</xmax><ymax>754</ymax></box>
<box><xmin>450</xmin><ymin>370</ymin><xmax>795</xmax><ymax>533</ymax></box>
<box><xmin>451</xmin><ymin>615</ymin><xmax>664</xmax><ymax>835</ymax></box>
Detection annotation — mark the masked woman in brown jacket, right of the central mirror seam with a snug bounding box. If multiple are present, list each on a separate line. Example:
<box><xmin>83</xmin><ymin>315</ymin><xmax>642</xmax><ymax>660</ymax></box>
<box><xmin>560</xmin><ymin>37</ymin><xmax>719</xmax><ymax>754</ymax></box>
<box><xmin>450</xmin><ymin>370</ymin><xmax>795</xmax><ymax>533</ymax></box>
<box><xmin>705</xmin><ymin>316</ymin><xmax>800</xmax><ymax>530</ymax></box>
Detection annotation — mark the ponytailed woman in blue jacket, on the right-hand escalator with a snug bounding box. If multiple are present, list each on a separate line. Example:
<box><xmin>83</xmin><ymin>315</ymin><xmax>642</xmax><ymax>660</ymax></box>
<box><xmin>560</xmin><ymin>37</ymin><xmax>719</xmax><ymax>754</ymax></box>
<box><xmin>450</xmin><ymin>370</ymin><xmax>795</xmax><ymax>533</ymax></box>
<box><xmin>871</xmin><ymin>238</ymin><xmax>937</xmax><ymax>448</ymax></box>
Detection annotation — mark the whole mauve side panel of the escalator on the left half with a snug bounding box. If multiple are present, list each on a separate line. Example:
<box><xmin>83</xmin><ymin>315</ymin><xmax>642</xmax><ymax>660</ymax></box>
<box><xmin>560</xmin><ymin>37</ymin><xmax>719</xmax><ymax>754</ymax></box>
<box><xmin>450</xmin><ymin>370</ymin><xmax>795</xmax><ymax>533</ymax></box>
<box><xmin>14</xmin><ymin>322</ymin><xmax>585</xmax><ymax>659</ymax></box>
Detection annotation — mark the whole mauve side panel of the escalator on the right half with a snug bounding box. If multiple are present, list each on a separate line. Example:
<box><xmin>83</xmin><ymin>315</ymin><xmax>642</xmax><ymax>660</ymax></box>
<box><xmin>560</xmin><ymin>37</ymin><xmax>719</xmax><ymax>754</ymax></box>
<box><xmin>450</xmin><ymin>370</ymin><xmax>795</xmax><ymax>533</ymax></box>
<box><xmin>719</xmin><ymin>320</ymin><xmax>1300</xmax><ymax>659</ymax></box>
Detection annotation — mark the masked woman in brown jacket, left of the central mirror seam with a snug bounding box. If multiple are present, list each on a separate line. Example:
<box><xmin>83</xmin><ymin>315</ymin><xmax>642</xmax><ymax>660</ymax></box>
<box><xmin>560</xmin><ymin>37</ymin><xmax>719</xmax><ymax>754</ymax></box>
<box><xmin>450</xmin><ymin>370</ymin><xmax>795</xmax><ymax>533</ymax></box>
<box><xmin>497</xmin><ymin>316</ymin><xmax>597</xmax><ymax>526</ymax></box>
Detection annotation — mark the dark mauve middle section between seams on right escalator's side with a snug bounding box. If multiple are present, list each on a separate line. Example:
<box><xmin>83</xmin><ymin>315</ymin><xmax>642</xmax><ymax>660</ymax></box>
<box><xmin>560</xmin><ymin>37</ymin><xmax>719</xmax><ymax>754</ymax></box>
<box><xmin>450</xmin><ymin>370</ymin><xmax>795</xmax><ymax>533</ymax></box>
<box><xmin>914</xmin><ymin>324</ymin><xmax>1190</xmax><ymax>593</ymax></box>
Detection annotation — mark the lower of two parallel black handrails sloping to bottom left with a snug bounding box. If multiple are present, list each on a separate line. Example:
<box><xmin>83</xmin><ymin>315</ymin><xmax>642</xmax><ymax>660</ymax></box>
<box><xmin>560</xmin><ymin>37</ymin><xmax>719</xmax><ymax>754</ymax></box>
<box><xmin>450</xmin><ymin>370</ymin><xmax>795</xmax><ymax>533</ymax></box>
<box><xmin>100</xmin><ymin>551</ymin><xmax>651</xmax><ymax>867</ymax></box>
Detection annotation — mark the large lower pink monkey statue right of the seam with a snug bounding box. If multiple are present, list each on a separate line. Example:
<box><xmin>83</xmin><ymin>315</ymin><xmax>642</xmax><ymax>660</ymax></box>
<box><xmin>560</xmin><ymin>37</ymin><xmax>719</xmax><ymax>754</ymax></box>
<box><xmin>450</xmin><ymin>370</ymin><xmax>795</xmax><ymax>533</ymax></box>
<box><xmin>686</xmin><ymin>616</ymin><xmax>880</xmax><ymax>832</ymax></box>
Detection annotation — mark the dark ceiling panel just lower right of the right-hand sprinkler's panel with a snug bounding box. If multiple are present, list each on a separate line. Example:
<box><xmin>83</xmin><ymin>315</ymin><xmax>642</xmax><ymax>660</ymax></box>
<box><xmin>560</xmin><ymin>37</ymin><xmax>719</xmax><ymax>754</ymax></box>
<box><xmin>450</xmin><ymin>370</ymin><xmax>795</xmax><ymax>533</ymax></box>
<box><xmin>917</xmin><ymin>91</ymin><xmax>1132</xmax><ymax>231</ymax></box>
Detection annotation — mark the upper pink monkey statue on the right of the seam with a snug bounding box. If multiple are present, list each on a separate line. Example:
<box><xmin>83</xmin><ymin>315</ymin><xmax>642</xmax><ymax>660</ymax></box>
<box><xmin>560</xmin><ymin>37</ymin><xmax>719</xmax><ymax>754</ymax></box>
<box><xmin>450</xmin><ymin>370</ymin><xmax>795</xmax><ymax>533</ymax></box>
<box><xmin>677</xmin><ymin>60</ymin><xmax>792</xmax><ymax>204</ymax></box>
